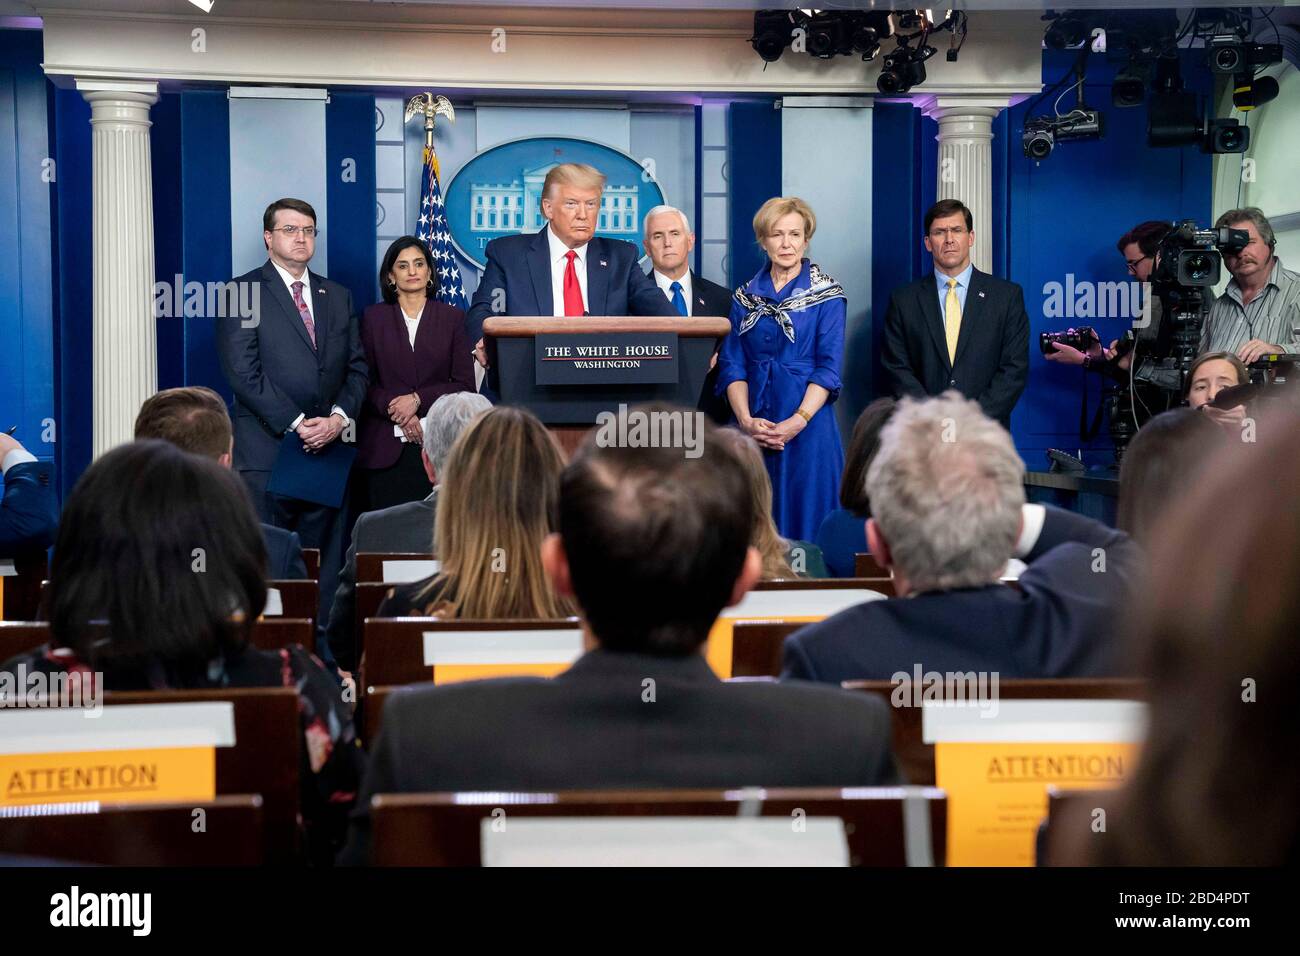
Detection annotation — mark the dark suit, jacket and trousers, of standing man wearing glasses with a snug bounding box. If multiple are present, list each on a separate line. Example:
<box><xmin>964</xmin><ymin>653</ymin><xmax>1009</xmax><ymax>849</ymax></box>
<box><xmin>217</xmin><ymin>260</ymin><xmax>369</xmax><ymax>655</ymax></box>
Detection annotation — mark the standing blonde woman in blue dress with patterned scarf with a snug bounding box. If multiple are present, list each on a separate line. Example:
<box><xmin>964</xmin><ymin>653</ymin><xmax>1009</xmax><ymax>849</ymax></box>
<box><xmin>718</xmin><ymin>196</ymin><xmax>846</xmax><ymax>540</ymax></box>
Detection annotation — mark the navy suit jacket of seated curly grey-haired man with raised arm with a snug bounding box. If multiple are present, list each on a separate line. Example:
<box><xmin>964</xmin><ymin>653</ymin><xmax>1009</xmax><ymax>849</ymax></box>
<box><xmin>783</xmin><ymin>507</ymin><xmax>1141</xmax><ymax>684</ymax></box>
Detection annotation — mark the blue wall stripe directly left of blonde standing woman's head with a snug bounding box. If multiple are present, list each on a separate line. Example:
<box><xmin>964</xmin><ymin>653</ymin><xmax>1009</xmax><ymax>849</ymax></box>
<box><xmin>727</xmin><ymin>100</ymin><xmax>781</xmax><ymax>289</ymax></box>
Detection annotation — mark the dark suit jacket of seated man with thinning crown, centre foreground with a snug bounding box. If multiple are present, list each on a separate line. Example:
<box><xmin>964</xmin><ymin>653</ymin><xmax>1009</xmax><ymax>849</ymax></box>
<box><xmin>343</xmin><ymin>650</ymin><xmax>898</xmax><ymax>864</ymax></box>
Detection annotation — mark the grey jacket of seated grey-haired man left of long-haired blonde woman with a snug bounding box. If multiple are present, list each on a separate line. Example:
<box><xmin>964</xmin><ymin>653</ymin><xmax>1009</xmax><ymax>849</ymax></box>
<box><xmin>324</xmin><ymin>488</ymin><xmax>438</xmax><ymax>671</ymax></box>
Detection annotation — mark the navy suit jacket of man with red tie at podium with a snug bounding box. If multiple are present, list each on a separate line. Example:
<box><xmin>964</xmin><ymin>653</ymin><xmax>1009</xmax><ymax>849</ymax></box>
<box><xmin>465</xmin><ymin>226</ymin><xmax>677</xmax><ymax>346</ymax></box>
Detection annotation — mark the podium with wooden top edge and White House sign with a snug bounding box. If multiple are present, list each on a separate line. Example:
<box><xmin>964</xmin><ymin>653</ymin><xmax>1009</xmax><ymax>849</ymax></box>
<box><xmin>484</xmin><ymin>316</ymin><xmax>731</xmax><ymax>454</ymax></box>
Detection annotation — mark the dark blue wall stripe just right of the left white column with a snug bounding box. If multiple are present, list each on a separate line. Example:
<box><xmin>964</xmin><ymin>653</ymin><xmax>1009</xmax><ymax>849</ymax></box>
<box><xmin>180</xmin><ymin>90</ymin><xmax>233</xmax><ymax>402</ymax></box>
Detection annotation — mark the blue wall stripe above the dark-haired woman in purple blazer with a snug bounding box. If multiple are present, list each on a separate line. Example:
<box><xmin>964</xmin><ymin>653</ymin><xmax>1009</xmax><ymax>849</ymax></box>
<box><xmin>325</xmin><ymin>90</ymin><xmax>380</xmax><ymax>315</ymax></box>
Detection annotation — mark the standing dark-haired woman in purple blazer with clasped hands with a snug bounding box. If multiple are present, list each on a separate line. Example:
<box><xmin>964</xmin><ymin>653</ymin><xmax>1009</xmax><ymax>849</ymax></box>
<box><xmin>358</xmin><ymin>235</ymin><xmax>475</xmax><ymax>511</ymax></box>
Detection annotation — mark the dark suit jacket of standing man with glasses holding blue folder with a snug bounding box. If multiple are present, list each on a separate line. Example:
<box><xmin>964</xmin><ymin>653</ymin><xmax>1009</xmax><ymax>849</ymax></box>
<box><xmin>217</xmin><ymin>261</ymin><xmax>368</xmax><ymax>471</ymax></box>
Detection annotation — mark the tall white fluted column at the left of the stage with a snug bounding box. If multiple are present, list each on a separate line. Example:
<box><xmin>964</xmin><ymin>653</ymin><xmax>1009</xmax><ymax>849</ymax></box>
<box><xmin>77</xmin><ymin>79</ymin><xmax>159</xmax><ymax>458</ymax></box>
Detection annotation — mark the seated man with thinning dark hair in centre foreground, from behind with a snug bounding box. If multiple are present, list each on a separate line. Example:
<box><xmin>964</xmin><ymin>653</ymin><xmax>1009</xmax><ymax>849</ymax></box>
<box><xmin>345</xmin><ymin>406</ymin><xmax>897</xmax><ymax>862</ymax></box>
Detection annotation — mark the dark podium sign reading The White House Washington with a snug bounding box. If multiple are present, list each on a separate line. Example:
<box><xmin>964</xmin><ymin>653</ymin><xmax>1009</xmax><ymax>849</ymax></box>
<box><xmin>533</xmin><ymin>332</ymin><xmax>679</xmax><ymax>385</ymax></box>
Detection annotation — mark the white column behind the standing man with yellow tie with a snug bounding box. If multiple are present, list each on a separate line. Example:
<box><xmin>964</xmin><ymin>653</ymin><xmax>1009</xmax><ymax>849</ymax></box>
<box><xmin>923</xmin><ymin>95</ymin><xmax>1010</xmax><ymax>272</ymax></box>
